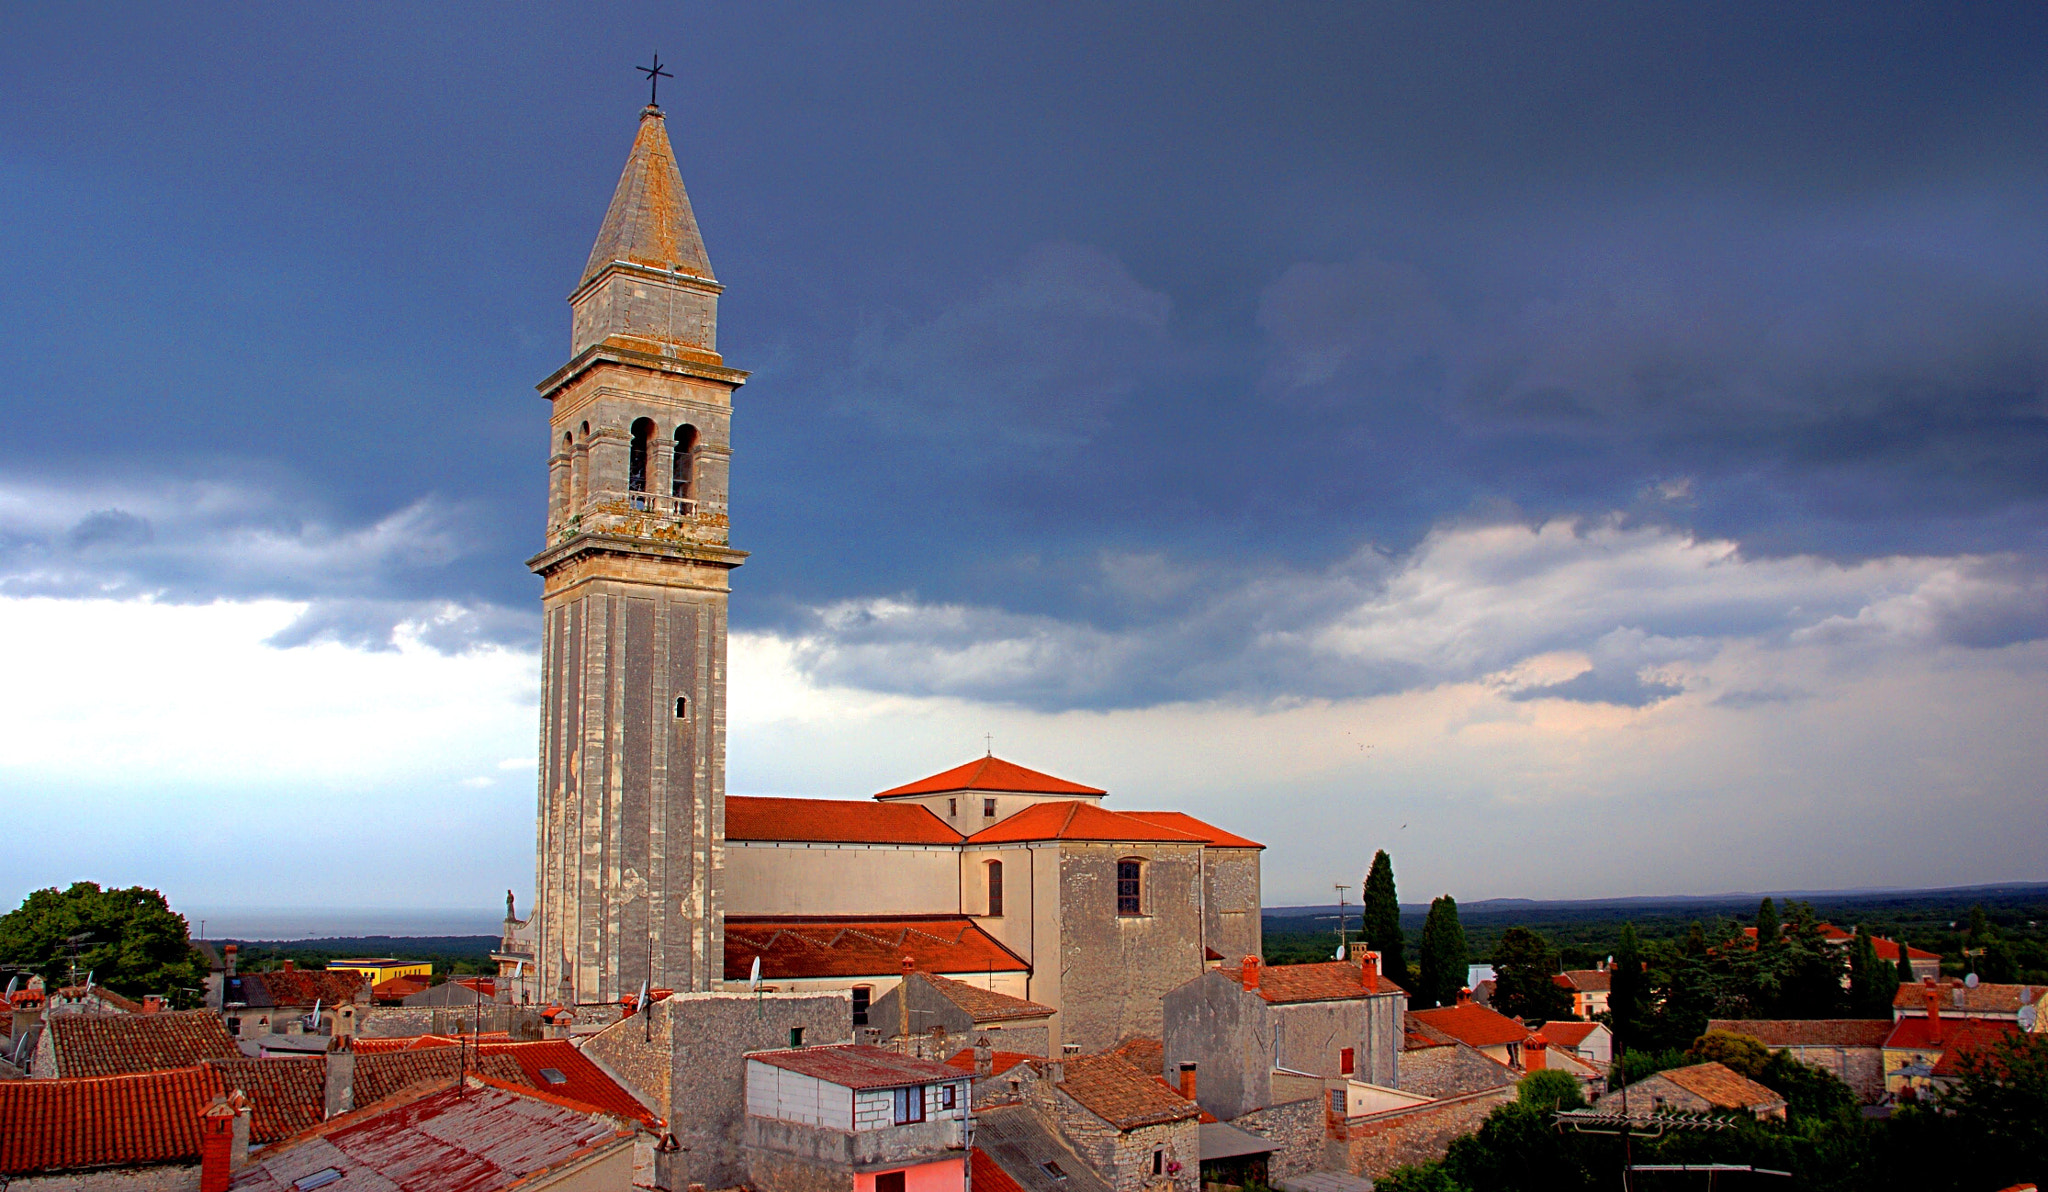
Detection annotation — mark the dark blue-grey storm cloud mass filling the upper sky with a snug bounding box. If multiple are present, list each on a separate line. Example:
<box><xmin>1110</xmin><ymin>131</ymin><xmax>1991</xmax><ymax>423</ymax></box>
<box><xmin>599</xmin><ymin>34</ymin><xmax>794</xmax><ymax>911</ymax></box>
<box><xmin>0</xmin><ymin>4</ymin><xmax>2048</xmax><ymax>707</ymax></box>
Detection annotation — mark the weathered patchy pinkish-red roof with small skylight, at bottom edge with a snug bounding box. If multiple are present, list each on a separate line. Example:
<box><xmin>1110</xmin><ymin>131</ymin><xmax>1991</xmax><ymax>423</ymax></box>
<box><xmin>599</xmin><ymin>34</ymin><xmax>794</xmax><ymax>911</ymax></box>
<box><xmin>231</xmin><ymin>1081</ymin><xmax>633</xmax><ymax>1192</ymax></box>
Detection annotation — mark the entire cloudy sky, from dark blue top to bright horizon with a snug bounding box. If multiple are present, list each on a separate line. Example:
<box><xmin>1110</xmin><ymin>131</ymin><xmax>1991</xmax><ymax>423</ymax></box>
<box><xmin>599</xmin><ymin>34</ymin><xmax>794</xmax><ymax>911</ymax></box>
<box><xmin>0</xmin><ymin>4</ymin><xmax>2048</xmax><ymax>905</ymax></box>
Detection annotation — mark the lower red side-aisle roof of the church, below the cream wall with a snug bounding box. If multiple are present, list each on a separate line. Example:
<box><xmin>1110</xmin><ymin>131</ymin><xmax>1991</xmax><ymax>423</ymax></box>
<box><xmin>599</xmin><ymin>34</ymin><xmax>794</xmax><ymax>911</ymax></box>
<box><xmin>725</xmin><ymin>916</ymin><xmax>1030</xmax><ymax>981</ymax></box>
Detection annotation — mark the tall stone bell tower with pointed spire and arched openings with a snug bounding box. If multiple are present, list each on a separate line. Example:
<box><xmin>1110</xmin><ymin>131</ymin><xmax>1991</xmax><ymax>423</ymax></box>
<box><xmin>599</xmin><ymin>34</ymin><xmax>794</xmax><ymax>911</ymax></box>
<box><xmin>526</xmin><ymin>104</ymin><xmax>748</xmax><ymax>1002</ymax></box>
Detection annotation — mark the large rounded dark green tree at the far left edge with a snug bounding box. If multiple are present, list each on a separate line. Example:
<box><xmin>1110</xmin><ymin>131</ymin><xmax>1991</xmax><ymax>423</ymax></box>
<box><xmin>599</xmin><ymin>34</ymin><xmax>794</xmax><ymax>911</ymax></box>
<box><xmin>0</xmin><ymin>881</ymin><xmax>203</xmax><ymax>1008</ymax></box>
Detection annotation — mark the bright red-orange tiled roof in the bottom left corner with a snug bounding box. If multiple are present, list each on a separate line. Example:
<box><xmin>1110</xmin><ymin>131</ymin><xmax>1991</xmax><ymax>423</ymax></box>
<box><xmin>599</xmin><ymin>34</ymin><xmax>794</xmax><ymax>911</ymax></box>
<box><xmin>0</xmin><ymin>1065</ymin><xmax>221</xmax><ymax>1176</ymax></box>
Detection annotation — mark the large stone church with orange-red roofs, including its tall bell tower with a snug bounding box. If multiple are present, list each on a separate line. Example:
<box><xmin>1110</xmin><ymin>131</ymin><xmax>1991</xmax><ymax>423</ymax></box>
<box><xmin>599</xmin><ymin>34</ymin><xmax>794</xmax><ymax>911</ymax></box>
<box><xmin>516</xmin><ymin>104</ymin><xmax>1262</xmax><ymax>1055</ymax></box>
